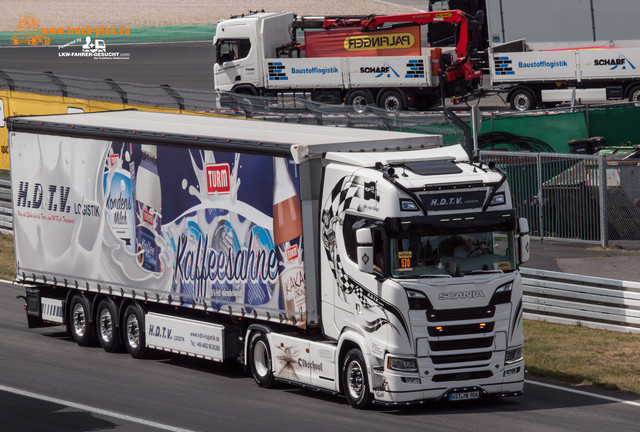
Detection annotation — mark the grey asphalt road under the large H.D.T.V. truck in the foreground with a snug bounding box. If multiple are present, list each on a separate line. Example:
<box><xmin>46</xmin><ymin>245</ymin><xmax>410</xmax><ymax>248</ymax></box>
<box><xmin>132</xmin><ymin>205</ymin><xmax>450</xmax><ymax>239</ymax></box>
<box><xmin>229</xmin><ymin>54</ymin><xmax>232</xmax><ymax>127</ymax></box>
<box><xmin>0</xmin><ymin>283</ymin><xmax>640</xmax><ymax>432</ymax></box>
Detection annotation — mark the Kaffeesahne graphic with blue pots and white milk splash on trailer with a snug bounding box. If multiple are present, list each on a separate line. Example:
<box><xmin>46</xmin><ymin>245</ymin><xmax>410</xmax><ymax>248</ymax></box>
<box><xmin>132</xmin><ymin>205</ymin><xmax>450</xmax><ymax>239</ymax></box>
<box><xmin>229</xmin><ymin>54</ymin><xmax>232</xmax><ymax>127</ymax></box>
<box><xmin>163</xmin><ymin>151</ymin><xmax>278</xmax><ymax>312</ymax></box>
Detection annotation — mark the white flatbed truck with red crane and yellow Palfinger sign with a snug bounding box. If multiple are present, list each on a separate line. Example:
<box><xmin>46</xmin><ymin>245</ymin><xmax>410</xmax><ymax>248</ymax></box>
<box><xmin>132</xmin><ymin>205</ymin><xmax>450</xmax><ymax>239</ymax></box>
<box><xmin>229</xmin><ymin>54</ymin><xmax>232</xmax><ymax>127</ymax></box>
<box><xmin>213</xmin><ymin>10</ymin><xmax>482</xmax><ymax>111</ymax></box>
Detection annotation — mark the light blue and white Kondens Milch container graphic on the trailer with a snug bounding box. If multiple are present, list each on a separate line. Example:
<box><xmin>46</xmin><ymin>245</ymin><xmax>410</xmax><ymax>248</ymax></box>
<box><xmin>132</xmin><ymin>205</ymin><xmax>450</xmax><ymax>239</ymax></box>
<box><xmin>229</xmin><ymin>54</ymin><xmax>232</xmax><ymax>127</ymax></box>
<box><xmin>102</xmin><ymin>142</ymin><xmax>136</xmax><ymax>254</ymax></box>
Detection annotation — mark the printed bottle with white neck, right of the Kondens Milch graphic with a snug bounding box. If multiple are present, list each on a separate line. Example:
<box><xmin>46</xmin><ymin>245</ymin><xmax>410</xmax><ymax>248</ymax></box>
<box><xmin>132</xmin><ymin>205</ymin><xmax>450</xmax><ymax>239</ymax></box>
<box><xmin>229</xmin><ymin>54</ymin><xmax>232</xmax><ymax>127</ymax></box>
<box><xmin>135</xmin><ymin>144</ymin><xmax>162</xmax><ymax>272</ymax></box>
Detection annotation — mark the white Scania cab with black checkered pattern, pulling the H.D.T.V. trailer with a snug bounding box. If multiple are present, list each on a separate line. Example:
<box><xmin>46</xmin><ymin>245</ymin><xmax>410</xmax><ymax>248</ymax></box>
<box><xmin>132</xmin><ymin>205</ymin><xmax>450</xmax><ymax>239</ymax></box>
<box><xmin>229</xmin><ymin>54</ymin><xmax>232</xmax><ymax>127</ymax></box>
<box><xmin>321</xmin><ymin>146</ymin><xmax>528</xmax><ymax>405</ymax></box>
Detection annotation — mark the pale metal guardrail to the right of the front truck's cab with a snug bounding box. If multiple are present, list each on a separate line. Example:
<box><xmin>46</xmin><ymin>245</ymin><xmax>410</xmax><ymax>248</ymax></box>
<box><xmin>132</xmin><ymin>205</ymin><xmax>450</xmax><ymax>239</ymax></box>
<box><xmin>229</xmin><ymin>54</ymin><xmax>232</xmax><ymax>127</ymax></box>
<box><xmin>521</xmin><ymin>268</ymin><xmax>640</xmax><ymax>333</ymax></box>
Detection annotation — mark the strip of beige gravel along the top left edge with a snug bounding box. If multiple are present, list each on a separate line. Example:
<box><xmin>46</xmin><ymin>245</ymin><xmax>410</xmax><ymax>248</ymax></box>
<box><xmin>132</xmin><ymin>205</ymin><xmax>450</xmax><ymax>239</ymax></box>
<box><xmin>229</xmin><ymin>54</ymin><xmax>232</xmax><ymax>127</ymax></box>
<box><xmin>0</xmin><ymin>0</ymin><xmax>416</xmax><ymax>31</ymax></box>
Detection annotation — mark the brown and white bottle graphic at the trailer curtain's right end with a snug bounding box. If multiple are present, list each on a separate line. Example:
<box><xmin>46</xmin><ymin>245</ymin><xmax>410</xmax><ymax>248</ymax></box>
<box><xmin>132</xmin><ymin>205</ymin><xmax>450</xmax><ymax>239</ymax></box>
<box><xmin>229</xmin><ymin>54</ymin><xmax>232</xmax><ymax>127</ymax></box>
<box><xmin>273</xmin><ymin>158</ymin><xmax>307</xmax><ymax>327</ymax></box>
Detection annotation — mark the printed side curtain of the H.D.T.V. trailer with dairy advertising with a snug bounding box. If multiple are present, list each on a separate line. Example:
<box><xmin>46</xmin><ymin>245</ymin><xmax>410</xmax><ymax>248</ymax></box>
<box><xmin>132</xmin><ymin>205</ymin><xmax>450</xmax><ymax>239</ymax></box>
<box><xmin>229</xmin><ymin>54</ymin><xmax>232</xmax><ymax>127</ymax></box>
<box><xmin>11</xmin><ymin>134</ymin><xmax>306</xmax><ymax>326</ymax></box>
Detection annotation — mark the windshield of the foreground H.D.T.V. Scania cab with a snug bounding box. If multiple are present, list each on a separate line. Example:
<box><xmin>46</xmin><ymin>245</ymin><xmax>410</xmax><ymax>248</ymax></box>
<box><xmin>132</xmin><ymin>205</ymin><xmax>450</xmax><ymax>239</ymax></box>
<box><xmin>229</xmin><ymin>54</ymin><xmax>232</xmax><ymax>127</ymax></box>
<box><xmin>390</xmin><ymin>231</ymin><xmax>516</xmax><ymax>278</ymax></box>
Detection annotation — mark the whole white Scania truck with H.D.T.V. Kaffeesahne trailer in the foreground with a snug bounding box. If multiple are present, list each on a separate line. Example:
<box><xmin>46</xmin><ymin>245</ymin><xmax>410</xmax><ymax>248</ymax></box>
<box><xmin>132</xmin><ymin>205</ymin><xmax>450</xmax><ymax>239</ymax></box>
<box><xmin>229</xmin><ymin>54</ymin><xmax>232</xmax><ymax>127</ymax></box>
<box><xmin>8</xmin><ymin>111</ymin><xmax>529</xmax><ymax>408</ymax></box>
